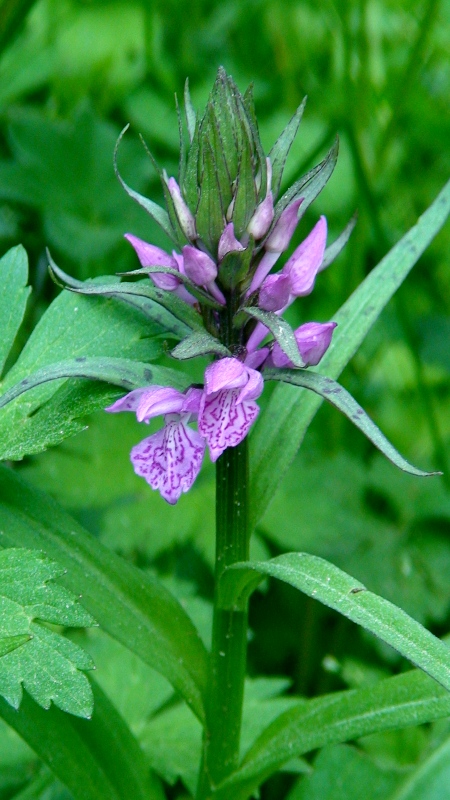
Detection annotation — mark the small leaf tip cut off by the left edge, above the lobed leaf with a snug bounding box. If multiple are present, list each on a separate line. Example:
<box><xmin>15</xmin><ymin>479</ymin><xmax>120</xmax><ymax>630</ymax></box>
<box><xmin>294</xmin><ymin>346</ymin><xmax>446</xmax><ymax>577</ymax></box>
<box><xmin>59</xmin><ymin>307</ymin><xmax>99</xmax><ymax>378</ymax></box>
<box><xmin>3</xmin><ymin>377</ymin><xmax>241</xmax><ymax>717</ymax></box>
<box><xmin>0</xmin><ymin>245</ymin><xmax>30</xmax><ymax>375</ymax></box>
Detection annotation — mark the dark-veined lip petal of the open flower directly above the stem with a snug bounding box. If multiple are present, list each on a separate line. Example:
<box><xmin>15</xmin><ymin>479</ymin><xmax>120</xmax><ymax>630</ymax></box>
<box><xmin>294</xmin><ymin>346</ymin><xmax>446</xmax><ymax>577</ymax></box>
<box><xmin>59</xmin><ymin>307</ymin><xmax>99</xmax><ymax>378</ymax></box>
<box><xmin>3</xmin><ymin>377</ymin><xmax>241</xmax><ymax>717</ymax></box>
<box><xmin>198</xmin><ymin>389</ymin><xmax>259</xmax><ymax>461</ymax></box>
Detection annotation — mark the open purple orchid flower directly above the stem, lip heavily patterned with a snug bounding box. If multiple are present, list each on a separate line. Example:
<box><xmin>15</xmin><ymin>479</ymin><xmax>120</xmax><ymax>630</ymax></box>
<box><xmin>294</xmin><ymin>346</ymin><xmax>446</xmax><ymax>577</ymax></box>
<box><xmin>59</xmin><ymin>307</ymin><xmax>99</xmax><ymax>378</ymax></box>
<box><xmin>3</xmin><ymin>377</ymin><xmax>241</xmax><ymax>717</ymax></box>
<box><xmin>198</xmin><ymin>358</ymin><xmax>264</xmax><ymax>461</ymax></box>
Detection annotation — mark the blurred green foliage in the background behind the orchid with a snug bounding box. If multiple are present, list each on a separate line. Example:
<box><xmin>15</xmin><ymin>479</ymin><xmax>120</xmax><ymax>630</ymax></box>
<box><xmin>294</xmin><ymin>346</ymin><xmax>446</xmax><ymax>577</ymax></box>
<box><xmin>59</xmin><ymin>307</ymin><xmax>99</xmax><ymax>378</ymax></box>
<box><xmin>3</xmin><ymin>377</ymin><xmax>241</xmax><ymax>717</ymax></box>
<box><xmin>0</xmin><ymin>0</ymin><xmax>450</xmax><ymax>800</ymax></box>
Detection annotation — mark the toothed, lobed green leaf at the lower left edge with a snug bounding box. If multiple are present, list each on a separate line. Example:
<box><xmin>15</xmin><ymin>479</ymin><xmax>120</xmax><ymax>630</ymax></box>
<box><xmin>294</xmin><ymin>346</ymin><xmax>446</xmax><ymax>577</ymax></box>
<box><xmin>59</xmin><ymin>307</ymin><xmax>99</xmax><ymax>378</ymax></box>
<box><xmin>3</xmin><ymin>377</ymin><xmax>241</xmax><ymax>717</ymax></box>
<box><xmin>0</xmin><ymin>548</ymin><xmax>94</xmax><ymax>717</ymax></box>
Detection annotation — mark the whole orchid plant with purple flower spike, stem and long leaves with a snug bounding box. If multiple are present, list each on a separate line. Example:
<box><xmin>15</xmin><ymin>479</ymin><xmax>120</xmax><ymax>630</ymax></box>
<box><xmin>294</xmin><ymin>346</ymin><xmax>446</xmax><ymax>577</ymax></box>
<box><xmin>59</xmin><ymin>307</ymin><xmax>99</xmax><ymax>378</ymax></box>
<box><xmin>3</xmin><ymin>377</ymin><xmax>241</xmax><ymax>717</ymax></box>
<box><xmin>0</xmin><ymin>69</ymin><xmax>450</xmax><ymax>800</ymax></box>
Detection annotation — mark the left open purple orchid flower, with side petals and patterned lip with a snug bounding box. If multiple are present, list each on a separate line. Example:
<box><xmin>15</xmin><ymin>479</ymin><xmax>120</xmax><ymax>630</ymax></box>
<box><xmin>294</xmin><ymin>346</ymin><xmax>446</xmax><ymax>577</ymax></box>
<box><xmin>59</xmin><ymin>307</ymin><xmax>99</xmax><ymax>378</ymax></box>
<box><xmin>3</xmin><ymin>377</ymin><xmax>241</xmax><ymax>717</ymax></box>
<box><xmin>106</xmin><ymin>386</ymin><xmax>205</xmax><ymax>505</ymax></box>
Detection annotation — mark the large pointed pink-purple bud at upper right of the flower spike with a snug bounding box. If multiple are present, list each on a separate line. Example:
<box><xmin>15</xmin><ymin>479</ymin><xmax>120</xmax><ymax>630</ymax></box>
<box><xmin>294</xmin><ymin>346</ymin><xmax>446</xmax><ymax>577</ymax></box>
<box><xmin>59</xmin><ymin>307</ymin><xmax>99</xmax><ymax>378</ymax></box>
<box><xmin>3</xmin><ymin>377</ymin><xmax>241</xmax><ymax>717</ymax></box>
<box><xmin>283</xmin><ymin>217</ymin><xmax>327</xmax><ymax>297</ymax></box>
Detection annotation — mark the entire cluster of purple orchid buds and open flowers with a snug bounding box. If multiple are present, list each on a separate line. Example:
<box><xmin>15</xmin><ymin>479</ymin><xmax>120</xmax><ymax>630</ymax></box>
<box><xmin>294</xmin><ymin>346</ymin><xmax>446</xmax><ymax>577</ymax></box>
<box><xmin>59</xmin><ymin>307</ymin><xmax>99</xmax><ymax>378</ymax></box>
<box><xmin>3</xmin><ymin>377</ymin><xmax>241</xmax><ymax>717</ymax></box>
<box><xmin>107</xmin><ymin>171</ymin><xmax>336</xmax><ymax>504</ymax></box>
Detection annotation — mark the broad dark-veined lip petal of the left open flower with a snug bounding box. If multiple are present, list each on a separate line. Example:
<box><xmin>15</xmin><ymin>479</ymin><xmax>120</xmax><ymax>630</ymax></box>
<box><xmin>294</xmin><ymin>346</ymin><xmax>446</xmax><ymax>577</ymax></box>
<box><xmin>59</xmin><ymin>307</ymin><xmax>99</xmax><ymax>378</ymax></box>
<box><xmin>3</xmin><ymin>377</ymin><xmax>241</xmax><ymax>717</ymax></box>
<box><xmin>131</xmin><ymin>419</ymin><xmax>205</xmax><ymax>505</ymax></box>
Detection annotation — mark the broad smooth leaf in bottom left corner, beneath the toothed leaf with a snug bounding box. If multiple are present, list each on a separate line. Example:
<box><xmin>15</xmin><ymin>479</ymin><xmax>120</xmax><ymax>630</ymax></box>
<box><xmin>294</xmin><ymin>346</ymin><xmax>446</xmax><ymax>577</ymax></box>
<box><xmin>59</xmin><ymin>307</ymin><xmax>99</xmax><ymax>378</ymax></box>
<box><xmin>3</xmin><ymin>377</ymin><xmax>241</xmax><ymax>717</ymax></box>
<box><xmin>0</xmin><ymin>683</ymin><xmax>163</xmax><ymax>800</ymax></box>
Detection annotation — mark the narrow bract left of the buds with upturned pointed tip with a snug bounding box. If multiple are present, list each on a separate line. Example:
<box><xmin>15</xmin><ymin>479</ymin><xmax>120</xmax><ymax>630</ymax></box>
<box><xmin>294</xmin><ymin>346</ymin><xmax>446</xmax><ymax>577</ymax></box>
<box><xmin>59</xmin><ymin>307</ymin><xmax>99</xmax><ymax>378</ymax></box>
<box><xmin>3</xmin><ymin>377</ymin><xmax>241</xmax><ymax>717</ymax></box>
<box><xmin>47</xmin><ymin>253</ymin><xmax>203</xmax><ymax>329</ymax></box>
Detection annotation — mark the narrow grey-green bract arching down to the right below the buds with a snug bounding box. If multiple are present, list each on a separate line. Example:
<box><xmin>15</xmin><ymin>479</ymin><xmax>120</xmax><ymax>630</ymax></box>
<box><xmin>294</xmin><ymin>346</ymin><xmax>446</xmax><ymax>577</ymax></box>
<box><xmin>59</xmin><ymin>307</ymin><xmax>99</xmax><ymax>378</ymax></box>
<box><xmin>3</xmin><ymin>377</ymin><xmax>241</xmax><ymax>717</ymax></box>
<box><xmin>264</xmin><ymin>369</ymin><xmax>441</xmax><ymax>477</ymax></box>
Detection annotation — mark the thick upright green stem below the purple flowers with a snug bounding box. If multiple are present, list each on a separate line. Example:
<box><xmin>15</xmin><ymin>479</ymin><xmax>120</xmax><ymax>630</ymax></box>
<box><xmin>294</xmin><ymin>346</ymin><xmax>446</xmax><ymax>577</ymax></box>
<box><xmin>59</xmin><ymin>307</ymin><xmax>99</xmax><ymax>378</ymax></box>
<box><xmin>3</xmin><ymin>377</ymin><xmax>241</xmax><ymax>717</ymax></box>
<box><xmin>197</xmin><ymin>439</ymin><xmax>249</xmax><ymax>800</ymax></box>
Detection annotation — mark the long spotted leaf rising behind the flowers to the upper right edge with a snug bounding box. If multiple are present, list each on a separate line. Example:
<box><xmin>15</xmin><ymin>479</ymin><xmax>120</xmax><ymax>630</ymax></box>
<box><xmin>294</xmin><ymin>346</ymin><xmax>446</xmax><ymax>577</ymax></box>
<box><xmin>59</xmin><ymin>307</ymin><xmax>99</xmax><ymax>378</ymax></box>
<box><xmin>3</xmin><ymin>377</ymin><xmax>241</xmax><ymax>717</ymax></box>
<box><xmin>250</xmin><ymin>183</ymin><xmax>450</xmax><ymax>525</ymax></box>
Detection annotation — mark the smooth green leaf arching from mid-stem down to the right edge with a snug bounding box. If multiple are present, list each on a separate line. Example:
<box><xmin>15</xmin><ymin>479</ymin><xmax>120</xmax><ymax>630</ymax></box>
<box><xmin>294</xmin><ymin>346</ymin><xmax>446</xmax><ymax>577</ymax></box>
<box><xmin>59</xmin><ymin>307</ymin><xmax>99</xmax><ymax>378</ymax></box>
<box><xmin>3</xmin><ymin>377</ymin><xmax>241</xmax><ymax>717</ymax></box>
<box><xmin>219</xmin><ymin>553</ymin><xmax>450</xmax><ymax>691</ymax></box>
